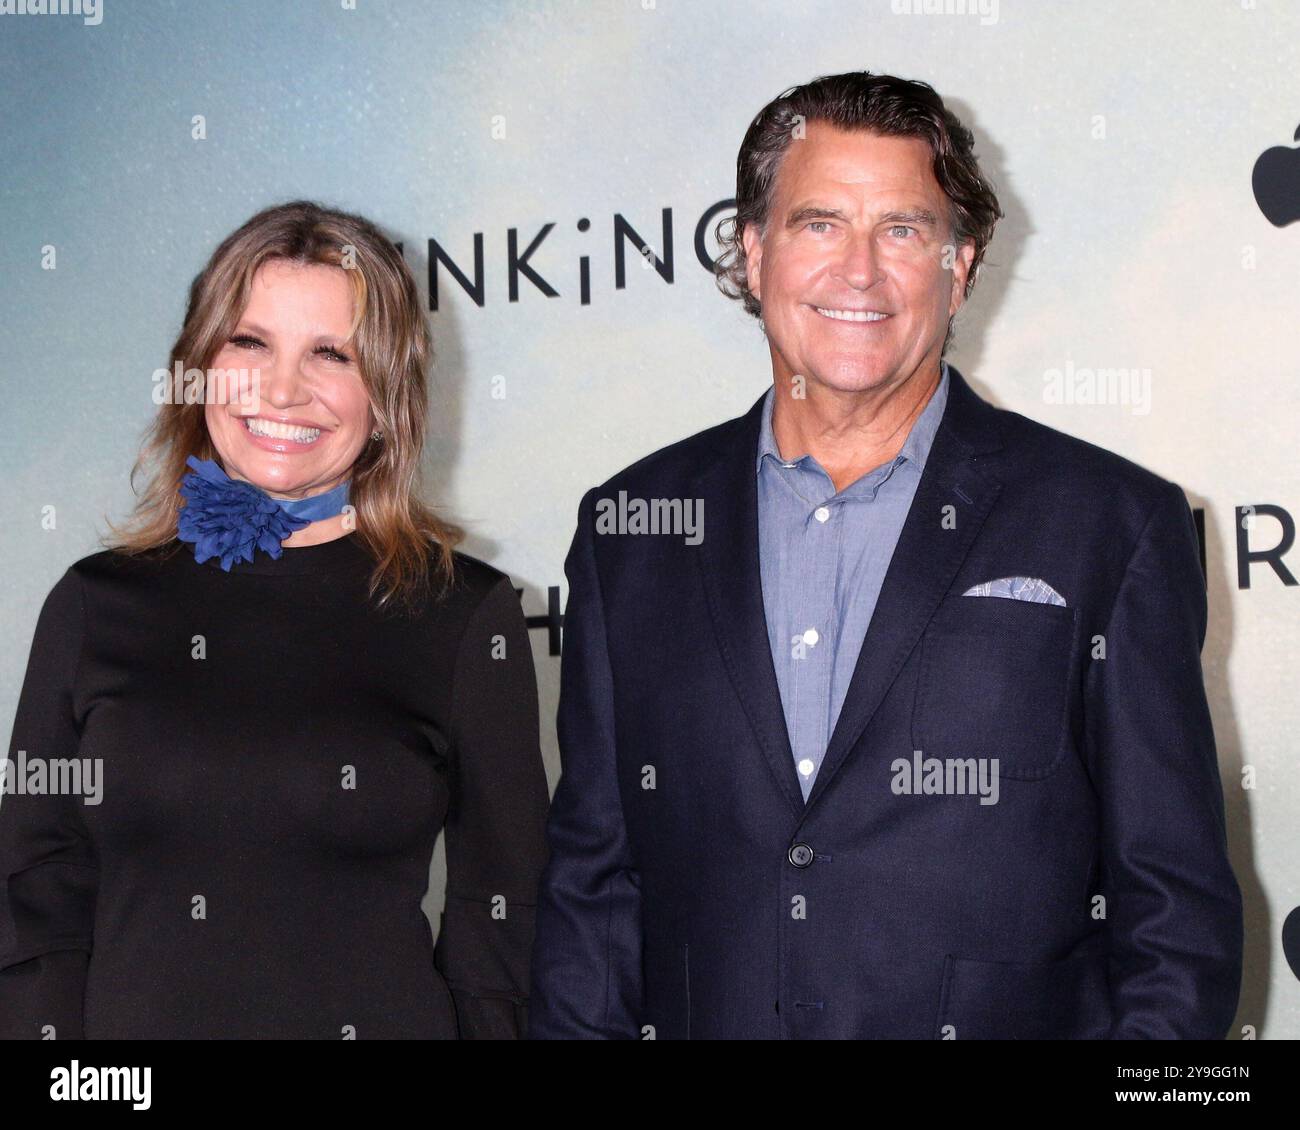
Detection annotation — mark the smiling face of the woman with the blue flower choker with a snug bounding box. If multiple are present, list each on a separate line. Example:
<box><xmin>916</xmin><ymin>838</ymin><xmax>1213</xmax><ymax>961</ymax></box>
<box><xmin>205</xmin><ymin>259</ymin><xmax>374</xmax><ymax>498</ymax></box>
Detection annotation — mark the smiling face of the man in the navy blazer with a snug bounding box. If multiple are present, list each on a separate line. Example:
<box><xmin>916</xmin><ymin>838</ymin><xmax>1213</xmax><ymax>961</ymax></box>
<box><xmin>744</xmin><ymin>121</ymin><xmax>975</xmax><ymax>393</ymax></box>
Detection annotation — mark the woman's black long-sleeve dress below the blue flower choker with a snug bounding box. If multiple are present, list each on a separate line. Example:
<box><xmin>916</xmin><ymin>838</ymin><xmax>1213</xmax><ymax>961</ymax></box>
<box><xmin>0</xmin><ymin>536</ymin><xmax>547</xmax><ymax>1039</ymax></box>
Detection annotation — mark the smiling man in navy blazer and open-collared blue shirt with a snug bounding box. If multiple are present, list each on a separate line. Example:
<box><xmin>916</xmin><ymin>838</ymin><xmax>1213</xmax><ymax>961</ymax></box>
<box><xmin>530</xmin><ymin>74</ymin><xmax>1242</xmax><ymax>1039</ymax></box>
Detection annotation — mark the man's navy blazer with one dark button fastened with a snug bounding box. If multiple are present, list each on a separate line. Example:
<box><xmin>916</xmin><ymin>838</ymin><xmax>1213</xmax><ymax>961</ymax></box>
<box><xmin>529</xmin><ymin>369</ymin><xmax>1242</xmax><ymax>1039</ymax></box>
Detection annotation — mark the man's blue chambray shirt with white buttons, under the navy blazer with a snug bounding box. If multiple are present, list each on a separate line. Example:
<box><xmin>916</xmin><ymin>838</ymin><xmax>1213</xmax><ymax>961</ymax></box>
<box><xmin>758</xmin><ymin>361</ymin><xmax>948</xmax><ymax>801</ymax></box>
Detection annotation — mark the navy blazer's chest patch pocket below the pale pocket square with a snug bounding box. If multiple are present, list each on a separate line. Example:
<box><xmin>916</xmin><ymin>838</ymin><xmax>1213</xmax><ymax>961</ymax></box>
<box><xmin>913</xmin><ymin>597</ymin><xmax>1075</xmax><ymax>780</ymax></box>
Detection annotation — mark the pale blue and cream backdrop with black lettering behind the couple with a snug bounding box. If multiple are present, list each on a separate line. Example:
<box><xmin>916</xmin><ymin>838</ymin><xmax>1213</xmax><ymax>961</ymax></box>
<box><xmin>0</xmin><ymin>0</ymin><xmax>1300</xmax><ymax>1038</ymax></box>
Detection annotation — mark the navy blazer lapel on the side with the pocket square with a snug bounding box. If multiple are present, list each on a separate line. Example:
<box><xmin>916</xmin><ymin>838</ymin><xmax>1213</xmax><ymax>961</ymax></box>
<box><xmin>800</xmin><ymin>365</ymin><xmax>1002</xmax><ymax>811</ymax></box>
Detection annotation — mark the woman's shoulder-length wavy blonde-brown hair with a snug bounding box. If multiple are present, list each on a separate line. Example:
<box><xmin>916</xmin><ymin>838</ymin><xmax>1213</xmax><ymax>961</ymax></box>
<box><xmin>104</xmin><ymin>200</ymin><xmax>463</xmax><ymax>607</ymax></box>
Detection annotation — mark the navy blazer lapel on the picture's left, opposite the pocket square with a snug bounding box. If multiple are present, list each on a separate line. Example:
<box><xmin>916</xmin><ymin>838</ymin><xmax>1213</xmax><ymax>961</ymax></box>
<box><xmin>697</xmin><ymin>398</ymin><xmax>803</xmax><ymax>815</ymax></box>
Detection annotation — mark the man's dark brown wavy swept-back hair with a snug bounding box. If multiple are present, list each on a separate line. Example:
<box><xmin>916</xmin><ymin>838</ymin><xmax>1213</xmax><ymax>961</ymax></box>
<box><xmin>714</xmin><ymin>70</ymin><xmax>1002</xmax><ymax>350</ymax></box>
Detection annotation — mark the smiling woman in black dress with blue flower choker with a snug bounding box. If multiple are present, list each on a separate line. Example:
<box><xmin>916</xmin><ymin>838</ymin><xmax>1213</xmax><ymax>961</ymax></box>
<box><xmin>0</xmin><ymin>203</ymin><xmax>547</xmax><ymax>1039</ymax></box>
